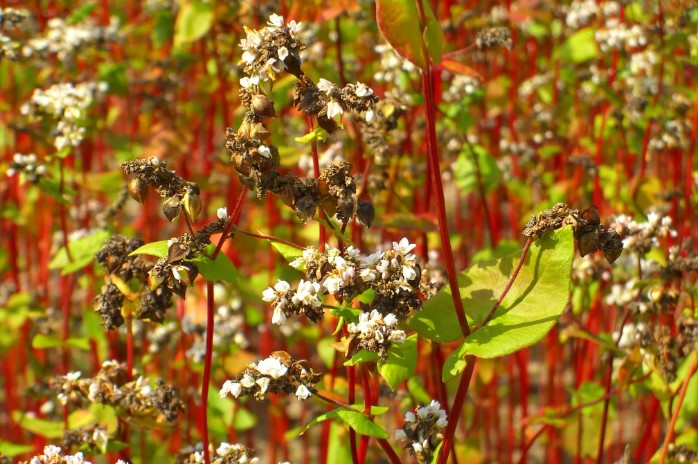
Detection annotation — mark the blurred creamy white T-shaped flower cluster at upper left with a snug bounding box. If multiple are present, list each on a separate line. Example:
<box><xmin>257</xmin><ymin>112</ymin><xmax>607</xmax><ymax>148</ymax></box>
<box><xmin>20</xmin><ymin>82</ymin><xmax>108</xmax><ymax>150</ymax></box>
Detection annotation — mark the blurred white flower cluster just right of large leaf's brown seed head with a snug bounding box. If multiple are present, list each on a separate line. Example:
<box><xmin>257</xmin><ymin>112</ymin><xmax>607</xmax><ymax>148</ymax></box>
<box><xmin>611</xmin><ymin>211</ymin><xmax>676</xmax><ymax>255</ymax></box>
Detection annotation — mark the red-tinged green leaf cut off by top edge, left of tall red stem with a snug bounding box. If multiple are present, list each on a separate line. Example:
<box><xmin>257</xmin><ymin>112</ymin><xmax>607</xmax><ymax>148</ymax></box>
<box><xmin>376</xmin><ymin>0</ymin><xmax>424</xmax><ymax>69</ymax></box>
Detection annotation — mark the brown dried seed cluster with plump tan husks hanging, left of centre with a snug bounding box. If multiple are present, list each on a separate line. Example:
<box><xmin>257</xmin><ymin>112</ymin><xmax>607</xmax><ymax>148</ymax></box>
<box><xmin>121</xmin><ymin>156</ymin><xmax>202</xmax><ymax>222</ymax></box>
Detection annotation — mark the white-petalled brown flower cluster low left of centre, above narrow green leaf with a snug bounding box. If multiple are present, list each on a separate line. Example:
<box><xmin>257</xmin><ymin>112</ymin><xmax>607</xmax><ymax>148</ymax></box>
<box><xmin>218</xmin><ymin>351</ymin><xmax>322</xmax><ymax>400</ymax></box>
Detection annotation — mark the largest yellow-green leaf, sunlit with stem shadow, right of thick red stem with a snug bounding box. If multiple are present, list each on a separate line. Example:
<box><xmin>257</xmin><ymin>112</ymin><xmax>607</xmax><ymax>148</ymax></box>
<box><xmin>444</xmin><ymin>227</ymin><xmax>574</xmax><ymax>373</ymax></box>
